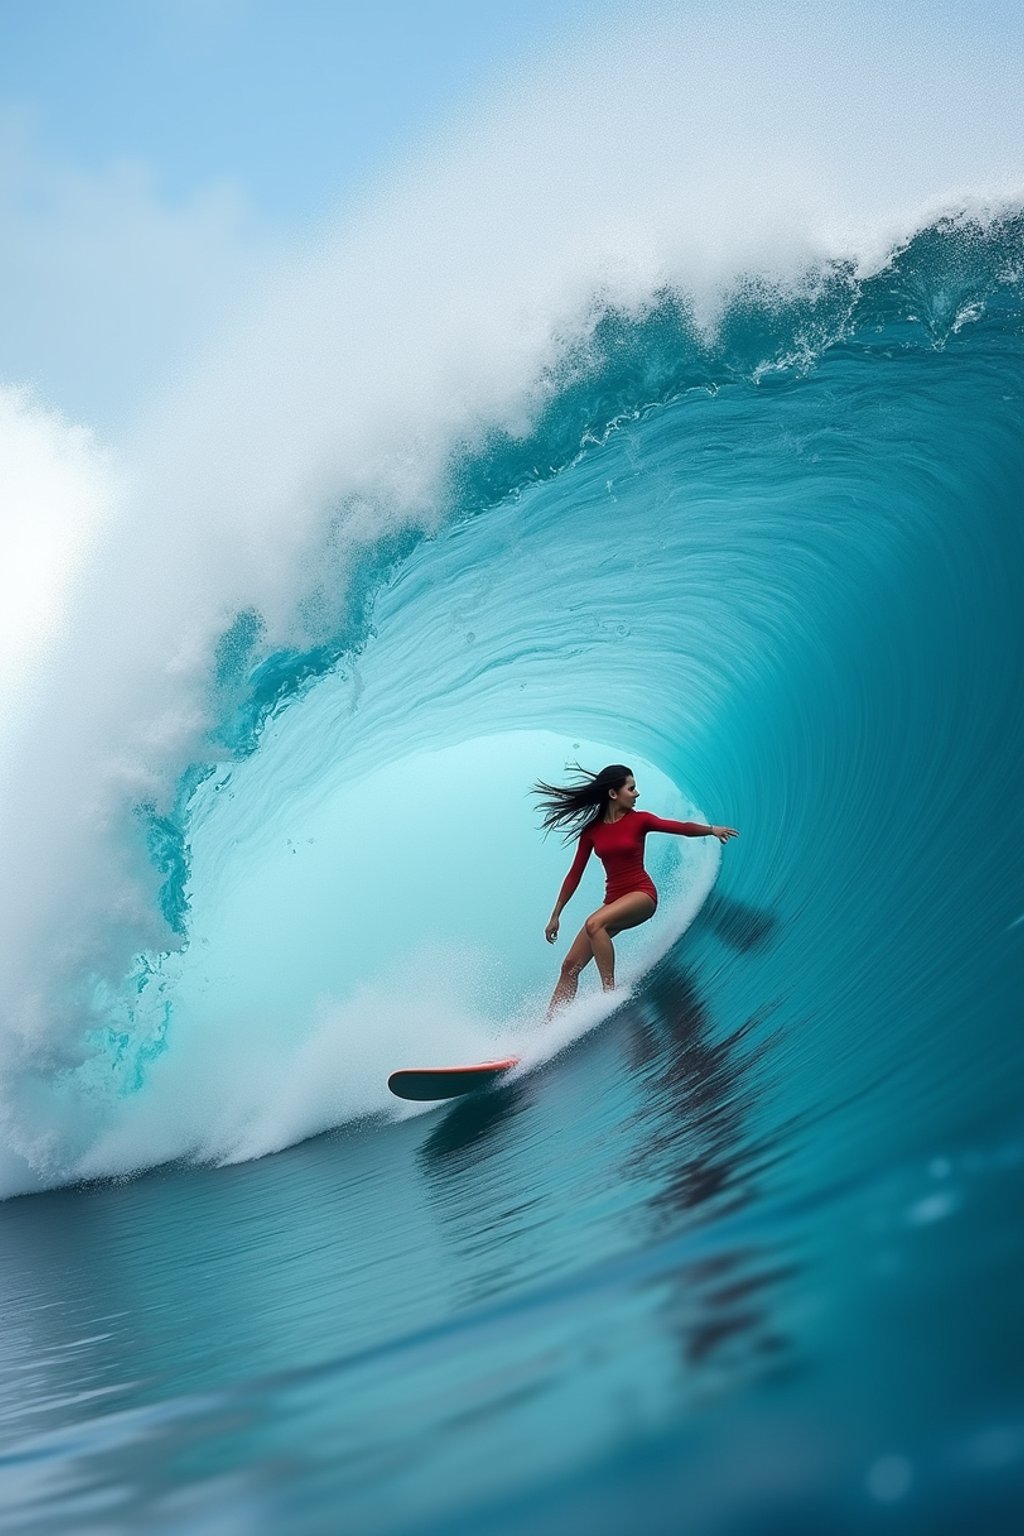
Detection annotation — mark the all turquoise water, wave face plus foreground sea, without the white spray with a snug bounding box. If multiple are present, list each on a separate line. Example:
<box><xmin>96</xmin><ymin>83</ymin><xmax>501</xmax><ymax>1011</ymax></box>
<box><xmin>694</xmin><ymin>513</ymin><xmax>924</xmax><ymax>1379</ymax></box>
<box><xmin>0</xmin><ymin>217</ymin><xmax>1024</xmax><ymax>1536</ymax></box>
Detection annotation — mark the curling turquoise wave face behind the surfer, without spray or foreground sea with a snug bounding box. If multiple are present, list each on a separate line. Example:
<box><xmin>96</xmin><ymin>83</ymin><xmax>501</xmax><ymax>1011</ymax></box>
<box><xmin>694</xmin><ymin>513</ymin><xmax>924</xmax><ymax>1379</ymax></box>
<box><xmin>6</xmin><ymin>210</ymin><xmax>1024</xmax><ymax>1192</ymax></box>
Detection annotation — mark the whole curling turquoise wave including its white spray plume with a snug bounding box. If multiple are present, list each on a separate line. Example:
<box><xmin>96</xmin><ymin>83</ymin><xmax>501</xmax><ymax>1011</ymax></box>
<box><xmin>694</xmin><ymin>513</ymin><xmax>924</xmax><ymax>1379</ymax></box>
<box><xmin>0</xmin><ymin>0</ymin><xmax>1024</xmax><ymax>1192</ymax></box>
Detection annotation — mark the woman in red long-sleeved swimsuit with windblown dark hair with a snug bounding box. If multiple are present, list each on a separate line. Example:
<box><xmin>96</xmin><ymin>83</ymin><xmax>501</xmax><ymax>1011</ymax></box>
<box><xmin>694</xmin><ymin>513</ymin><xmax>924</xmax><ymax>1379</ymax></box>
<box><xmin>533</xmin><ymin>763</ymin><xmax>740</xmax><ymax>1018</ymax></box>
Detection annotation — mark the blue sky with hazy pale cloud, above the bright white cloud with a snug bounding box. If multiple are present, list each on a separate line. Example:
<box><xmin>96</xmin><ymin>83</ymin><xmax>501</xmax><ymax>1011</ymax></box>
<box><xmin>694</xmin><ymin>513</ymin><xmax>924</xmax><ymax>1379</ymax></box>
<box><xmin>0</xmin><ymin>0</ymin><xmax>595</xmax><ymax>430</ymax></box>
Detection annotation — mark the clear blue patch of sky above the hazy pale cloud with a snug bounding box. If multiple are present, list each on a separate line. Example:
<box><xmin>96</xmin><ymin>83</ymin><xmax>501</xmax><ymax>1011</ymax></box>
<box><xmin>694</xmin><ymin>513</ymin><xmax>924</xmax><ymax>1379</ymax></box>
<box><xmin>0</xmin><ymin>0</ymin><xmax>600</xmax><ymax>221</ymax></box>
